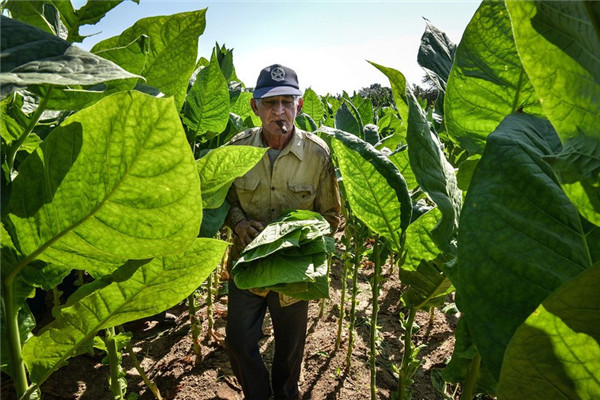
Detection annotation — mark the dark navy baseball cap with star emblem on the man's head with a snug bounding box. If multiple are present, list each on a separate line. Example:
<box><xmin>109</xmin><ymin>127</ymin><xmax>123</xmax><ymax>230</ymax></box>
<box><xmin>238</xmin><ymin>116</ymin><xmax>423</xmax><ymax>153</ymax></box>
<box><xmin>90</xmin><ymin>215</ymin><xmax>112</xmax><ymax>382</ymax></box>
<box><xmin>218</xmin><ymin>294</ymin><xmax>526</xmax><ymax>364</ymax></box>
<box><xmin>254</xmin><ymin>64</ymin><xmax>302</xmax><ymax>99</ymax></box>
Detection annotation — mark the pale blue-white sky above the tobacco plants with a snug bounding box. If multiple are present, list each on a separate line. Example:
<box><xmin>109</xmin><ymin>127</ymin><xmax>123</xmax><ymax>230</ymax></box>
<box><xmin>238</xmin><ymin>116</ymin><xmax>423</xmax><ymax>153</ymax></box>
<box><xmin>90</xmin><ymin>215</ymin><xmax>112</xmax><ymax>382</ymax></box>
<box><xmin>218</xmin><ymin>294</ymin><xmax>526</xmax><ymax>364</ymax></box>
<box><xmin>75</xmin><ymin>0</ymin><xmax>480</xmax><ymax>95</ymax></box>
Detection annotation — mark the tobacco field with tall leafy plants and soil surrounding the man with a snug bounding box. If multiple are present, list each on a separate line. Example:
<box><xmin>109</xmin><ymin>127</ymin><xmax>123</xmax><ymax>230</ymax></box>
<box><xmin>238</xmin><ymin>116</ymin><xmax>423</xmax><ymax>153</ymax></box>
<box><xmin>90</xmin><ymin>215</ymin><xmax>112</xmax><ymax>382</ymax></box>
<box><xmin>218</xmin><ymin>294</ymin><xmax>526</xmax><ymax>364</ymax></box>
<box><xmin>0</xmin><ymin>0</ymin><xmax>600</xmax><ymax>400</ymax></box>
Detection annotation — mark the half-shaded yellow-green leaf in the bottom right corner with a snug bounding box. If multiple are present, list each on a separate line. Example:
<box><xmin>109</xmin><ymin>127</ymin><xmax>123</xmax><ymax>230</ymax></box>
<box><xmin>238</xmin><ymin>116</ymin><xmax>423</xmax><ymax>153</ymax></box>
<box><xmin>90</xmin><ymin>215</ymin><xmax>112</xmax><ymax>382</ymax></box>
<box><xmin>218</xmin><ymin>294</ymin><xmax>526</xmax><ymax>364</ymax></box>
<box><xmin>498</xmin><ymin>265</ymin><xmax>600</xmax><ymax>400</ymax></box>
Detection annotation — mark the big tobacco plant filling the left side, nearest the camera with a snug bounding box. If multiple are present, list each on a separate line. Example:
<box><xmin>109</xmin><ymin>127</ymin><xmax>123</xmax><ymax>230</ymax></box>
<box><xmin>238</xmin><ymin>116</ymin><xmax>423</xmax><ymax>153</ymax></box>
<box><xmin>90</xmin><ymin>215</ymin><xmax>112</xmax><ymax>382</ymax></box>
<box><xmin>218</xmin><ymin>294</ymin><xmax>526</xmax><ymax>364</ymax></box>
<box><xmin>0</xmin><ymin>2</ymin><xmax>262</xmax><ymax>398</ymax></box>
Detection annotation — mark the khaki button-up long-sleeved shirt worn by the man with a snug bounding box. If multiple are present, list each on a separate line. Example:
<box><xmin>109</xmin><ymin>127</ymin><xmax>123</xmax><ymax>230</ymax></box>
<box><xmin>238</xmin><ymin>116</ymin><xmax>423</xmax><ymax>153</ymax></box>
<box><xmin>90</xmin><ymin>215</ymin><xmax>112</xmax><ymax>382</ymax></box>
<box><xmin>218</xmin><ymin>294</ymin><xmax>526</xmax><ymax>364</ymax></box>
<box><xmin>227</xmin><ymin>127</ymin><xmax>341</xmax><ymax>302</ymax></box>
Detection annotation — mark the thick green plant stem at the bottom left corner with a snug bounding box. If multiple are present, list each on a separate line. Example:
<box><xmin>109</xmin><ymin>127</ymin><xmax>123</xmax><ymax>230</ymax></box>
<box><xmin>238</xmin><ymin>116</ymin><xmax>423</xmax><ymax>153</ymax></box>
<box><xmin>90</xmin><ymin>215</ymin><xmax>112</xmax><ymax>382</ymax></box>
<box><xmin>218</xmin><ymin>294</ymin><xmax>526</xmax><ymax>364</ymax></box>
<box><xmin>2</xmin><ymin>281</ymin><xmax>29</xmax><ymax>398</ymax></box>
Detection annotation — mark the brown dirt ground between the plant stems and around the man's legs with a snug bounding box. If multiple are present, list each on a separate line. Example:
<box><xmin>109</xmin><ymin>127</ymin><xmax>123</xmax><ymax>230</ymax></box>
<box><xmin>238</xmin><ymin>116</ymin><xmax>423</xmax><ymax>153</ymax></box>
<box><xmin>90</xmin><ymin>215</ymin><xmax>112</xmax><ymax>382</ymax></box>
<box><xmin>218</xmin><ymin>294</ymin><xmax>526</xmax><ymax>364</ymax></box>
<box><xmin>2</xmin><ymin>247</ymin><xmax>457</xmax><ymax>400</ymax></box>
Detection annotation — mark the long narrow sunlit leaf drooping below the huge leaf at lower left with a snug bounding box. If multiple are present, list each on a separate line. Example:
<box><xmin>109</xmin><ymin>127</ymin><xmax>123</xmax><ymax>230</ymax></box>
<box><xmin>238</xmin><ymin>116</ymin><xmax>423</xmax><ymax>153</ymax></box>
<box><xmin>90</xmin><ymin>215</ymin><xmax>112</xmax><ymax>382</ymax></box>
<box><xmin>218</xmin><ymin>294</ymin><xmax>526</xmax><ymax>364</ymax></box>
<box><xmin>23</xmin><ymin>238</ymin><xmax>227</xmax><ymax>384</ymax></box>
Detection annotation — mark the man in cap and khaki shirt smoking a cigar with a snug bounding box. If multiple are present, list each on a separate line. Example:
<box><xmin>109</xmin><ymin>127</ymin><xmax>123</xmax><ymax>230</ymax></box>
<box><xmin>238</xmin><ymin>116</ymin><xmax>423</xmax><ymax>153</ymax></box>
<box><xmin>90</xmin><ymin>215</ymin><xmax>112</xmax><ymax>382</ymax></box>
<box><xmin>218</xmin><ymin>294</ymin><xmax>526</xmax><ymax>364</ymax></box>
<box><xmin>226</xmin><ymin>64</ymin><xmax>340</xmax><ymax>400</ymax></box>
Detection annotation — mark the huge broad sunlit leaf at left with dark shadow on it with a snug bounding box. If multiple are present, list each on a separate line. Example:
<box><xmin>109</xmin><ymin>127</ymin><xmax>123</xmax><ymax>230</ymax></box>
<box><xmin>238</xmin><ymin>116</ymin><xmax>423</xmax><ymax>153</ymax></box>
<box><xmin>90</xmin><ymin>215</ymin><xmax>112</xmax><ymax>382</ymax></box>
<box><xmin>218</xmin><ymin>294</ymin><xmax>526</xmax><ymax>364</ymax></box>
<box><xmin>3</xmin><ymin>92</ymin><xmax>202</xmax><ymax>273</ymax></box>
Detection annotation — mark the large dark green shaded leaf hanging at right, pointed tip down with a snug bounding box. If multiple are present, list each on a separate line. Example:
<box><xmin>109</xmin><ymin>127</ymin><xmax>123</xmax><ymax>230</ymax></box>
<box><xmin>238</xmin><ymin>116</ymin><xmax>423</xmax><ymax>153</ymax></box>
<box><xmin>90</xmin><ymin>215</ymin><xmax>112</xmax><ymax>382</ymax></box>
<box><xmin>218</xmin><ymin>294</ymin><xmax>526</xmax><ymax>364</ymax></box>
<box><xmin>453</xmin><ymin>114</ymin><xmax>600</xmax><ymax>378</ymax></box>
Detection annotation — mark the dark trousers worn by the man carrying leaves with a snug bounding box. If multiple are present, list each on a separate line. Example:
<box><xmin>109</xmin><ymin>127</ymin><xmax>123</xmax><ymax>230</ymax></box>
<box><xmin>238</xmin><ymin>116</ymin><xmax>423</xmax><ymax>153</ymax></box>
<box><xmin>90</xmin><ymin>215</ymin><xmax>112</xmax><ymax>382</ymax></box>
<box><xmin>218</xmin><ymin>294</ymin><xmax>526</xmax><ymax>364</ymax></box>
<box><xmin>226</xmin><ymin>280</ymin><xmax>308</xmax><ymax>400</ymax></box>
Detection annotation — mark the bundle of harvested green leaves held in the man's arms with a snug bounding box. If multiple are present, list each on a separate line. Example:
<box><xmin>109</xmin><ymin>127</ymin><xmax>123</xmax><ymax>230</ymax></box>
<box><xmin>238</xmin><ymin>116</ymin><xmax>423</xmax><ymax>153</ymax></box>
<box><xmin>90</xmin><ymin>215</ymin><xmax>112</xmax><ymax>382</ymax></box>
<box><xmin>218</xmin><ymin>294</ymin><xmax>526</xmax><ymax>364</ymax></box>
<box><xmin>232</xmin><ymin>210</ymin><xmax>335</xmax><ymax>300</ymax></box>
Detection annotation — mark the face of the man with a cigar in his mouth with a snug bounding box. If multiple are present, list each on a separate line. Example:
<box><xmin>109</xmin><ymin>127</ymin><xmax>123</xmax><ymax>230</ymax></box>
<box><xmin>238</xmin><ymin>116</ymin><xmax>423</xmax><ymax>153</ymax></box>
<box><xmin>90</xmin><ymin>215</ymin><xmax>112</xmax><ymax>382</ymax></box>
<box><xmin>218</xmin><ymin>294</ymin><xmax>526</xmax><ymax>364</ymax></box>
<box><xmin>251</xmin><ymin>96</ymin><xmax>302</xmax><ymax>134</ymax></box>
